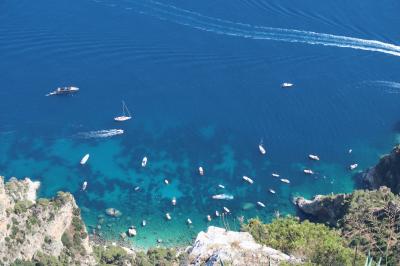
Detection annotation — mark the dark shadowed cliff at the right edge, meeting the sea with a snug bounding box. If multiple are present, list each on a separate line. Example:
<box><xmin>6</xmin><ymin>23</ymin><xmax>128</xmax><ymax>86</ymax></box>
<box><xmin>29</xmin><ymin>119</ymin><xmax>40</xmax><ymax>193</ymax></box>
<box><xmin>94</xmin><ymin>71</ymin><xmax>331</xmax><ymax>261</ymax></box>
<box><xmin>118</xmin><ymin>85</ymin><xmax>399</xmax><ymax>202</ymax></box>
<box><xmin>362</xmin><ymin>145</ymin><xmax>400</xmax><ymax>194</ymax></box>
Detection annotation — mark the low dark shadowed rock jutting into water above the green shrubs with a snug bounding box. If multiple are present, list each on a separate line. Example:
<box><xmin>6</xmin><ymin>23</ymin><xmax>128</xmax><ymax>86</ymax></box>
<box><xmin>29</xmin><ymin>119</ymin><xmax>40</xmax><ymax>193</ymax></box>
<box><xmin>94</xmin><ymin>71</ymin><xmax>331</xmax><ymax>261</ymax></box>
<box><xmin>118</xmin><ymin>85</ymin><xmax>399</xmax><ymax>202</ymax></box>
<box><xmin>294</xmin><ymin>194</ymin><xmax>351</xmax><ymax>226</ymax></box>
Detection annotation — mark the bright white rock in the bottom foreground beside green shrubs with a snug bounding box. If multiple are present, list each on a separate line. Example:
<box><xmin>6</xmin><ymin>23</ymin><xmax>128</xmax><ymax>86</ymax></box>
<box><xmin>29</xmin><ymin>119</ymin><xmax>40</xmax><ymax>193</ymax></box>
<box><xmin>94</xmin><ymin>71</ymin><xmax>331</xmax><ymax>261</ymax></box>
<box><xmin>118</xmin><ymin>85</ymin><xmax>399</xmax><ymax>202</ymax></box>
<box><xmin>189</xmin><ymin>226</ymin><xmax>300</xmax><ymax>266</ymax></box>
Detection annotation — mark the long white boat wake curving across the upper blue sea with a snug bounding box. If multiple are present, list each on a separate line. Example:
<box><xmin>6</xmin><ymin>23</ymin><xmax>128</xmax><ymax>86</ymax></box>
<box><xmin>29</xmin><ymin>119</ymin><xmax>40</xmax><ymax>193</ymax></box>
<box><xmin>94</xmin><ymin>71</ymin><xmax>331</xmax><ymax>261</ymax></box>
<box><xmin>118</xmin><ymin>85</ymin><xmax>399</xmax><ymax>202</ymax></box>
<box><xmin>96</xmin><ymin>0</ymin><xmax>400</xmax><ymax>56</ymax></box>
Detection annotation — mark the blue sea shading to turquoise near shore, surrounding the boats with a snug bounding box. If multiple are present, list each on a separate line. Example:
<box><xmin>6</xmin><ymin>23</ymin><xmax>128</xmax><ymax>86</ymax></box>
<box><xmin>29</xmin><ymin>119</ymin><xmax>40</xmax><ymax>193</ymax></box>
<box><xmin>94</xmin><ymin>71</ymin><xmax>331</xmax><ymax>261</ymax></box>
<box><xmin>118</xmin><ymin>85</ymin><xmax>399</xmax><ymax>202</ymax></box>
<box><xmin>0</xmin><ymin>0</ymin><xmax>400</xmax><ymax>247</ymax></box>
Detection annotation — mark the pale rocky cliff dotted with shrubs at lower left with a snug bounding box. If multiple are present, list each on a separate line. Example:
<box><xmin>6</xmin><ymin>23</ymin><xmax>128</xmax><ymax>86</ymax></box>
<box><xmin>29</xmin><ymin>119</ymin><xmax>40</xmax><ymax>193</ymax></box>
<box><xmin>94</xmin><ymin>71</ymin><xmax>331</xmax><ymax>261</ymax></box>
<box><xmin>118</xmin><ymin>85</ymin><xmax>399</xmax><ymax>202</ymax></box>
<box><xmin>0</xmin><ymin>177</ymin><xmax>95</xmax><ymax>265</ymax></box>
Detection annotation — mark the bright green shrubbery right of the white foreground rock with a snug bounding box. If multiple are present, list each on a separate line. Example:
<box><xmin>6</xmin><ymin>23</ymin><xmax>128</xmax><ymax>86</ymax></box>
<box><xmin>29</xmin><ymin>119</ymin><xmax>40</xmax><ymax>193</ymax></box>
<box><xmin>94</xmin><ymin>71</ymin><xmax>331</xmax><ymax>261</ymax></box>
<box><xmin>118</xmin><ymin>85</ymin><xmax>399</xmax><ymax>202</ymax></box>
<box><xmin>242</xmin><ymin>217</ymin><xmax>364</xmax><ymax>266</ymax></box>
